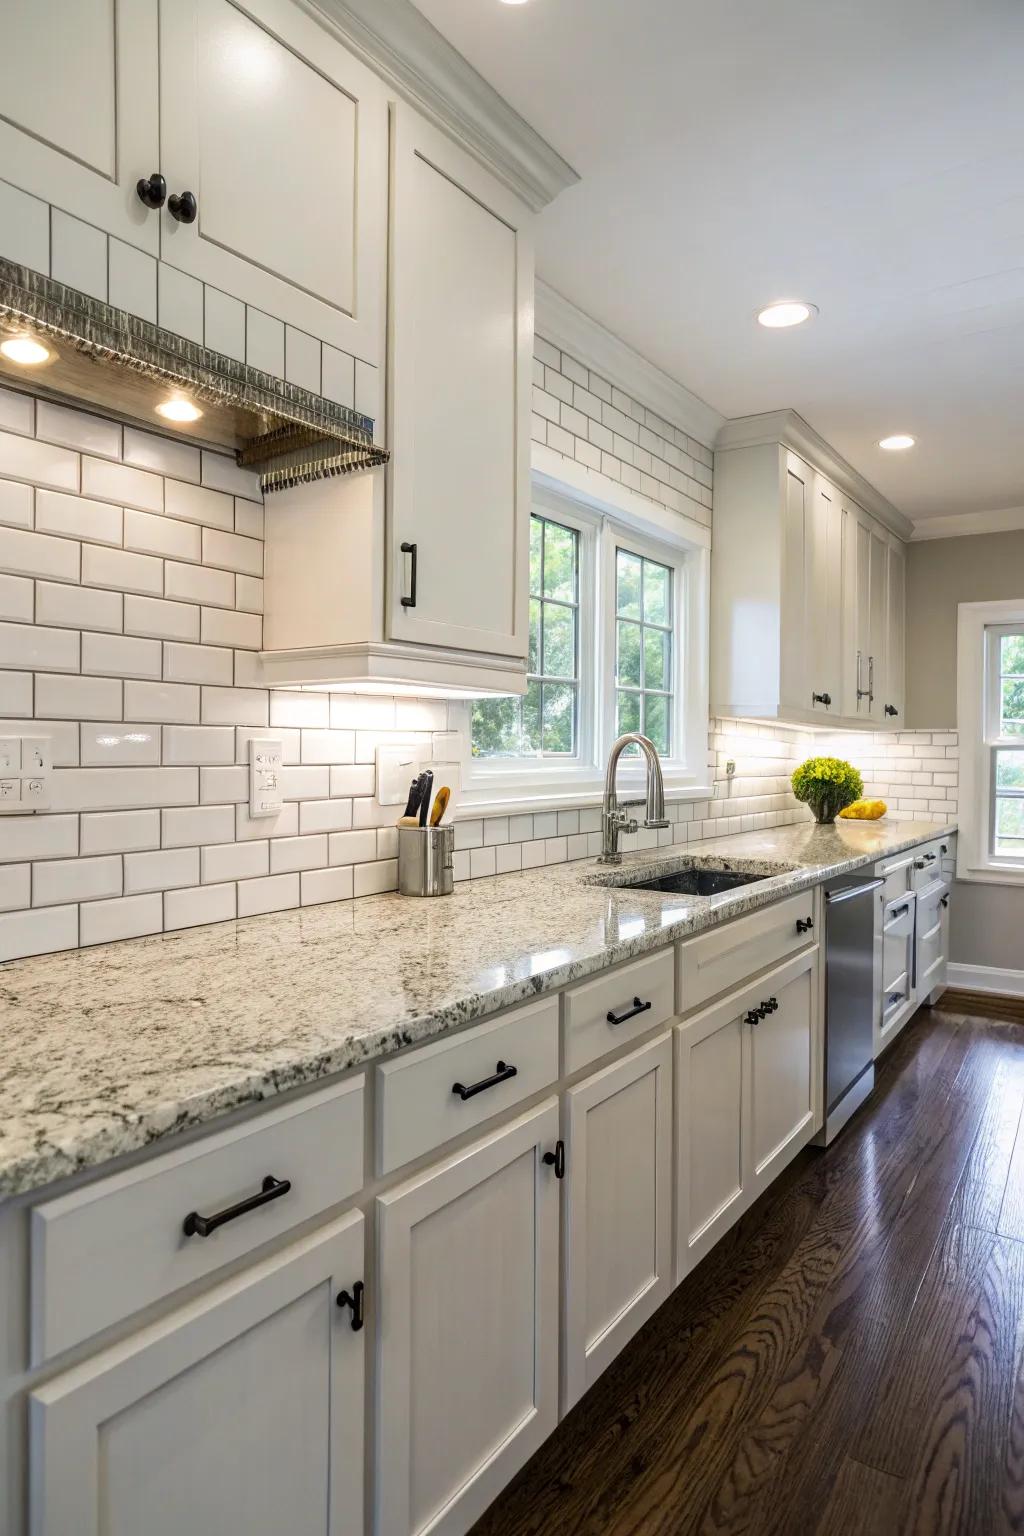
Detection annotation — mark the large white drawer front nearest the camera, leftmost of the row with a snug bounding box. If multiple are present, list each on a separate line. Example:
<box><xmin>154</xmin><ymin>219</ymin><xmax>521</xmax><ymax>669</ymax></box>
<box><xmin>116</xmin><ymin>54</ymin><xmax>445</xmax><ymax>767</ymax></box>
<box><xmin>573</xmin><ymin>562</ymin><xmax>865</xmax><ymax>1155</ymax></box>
<box><xmin>31</xmin><ymin>1074</ymin><xmax>364</xmax><ymax>1366</ymax></box>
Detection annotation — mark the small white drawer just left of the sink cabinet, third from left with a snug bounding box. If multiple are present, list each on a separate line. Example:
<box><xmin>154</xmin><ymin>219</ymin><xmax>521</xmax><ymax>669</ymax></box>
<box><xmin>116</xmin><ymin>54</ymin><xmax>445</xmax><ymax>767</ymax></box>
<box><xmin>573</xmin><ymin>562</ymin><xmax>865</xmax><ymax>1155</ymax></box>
<box><xmin>563</xmin><ymin>949</ymin><xmax>676</xmax><ymax>1074</ymax></box>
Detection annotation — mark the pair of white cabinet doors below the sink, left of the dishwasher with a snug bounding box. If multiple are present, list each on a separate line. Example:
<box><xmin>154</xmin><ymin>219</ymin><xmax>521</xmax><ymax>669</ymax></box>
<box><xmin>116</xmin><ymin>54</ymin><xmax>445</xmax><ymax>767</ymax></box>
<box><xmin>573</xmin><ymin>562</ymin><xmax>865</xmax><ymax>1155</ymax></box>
<box><xmin>676</xmin><ymin>949</ymin><xmax>820</xmax><ymax>1281</ymax></box>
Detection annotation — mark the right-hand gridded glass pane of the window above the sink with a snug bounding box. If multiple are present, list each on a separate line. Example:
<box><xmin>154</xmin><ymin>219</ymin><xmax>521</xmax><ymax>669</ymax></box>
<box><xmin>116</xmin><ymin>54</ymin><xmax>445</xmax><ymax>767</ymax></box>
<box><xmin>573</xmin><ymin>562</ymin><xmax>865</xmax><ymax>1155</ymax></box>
<box><xmin>616</xmin><ymin>547</ymin><xmax>674</xmax><ymax>756</ymax></box>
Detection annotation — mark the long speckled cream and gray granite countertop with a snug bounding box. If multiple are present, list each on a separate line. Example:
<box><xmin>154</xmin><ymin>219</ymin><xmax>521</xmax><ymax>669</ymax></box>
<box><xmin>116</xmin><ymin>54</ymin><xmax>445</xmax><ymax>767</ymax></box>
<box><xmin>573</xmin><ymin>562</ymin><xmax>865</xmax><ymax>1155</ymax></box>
<box><xmin>0</xmin><ymin>820</ymin><xmax>953</xmax><ymax>1200</ymax></box>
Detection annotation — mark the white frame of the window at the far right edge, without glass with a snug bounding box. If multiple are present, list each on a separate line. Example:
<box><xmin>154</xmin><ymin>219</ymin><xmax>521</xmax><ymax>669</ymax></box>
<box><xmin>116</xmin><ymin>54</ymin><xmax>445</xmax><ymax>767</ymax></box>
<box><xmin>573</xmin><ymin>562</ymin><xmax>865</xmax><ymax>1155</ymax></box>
<box><xmin>956</xmin><ymin>598</ymin><xmax>1024</xmax><ymax>885</ymax></box>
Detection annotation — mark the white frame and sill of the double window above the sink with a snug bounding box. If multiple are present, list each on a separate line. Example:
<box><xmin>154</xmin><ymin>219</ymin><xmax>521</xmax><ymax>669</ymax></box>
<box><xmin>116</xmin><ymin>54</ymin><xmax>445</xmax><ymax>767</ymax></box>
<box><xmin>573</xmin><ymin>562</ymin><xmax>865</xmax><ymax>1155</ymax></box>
<box><xmin>456</xmin><ymin>465</ymin><xmax>711</xmax><ymax>816</ymax></box>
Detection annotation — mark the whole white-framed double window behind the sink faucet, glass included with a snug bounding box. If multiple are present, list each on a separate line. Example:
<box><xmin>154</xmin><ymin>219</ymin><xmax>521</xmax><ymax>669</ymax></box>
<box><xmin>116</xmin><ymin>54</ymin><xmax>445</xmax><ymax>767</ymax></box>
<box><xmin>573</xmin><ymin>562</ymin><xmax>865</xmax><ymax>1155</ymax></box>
<box><xmin>462</xmin><ymin>482</ymin><xmax>709</xmax><ymax>809</ymax></box>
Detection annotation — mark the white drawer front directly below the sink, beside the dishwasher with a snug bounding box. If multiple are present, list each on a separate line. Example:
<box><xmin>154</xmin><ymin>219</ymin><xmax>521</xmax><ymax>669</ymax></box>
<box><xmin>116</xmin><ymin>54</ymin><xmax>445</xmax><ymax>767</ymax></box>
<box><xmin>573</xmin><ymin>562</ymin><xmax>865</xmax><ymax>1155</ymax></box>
<box><xmin>679</xmin><ymin>889</ymin><xmax>817</xmax><ymax>1014</ymax></box>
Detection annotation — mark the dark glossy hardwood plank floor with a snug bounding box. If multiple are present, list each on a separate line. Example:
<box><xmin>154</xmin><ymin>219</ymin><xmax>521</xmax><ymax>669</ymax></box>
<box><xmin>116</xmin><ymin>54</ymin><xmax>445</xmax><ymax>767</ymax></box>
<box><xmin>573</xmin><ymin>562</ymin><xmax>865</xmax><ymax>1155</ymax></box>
<box><xmin>473</xmin><ymin>1006</ymin><xmax>1024</xmax><ymax>1536</ymax></box>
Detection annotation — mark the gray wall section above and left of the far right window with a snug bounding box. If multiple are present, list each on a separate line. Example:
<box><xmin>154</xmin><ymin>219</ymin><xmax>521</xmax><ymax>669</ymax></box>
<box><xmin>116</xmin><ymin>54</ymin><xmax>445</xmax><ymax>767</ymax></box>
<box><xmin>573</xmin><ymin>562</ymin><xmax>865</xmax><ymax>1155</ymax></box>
<box><xmin>907</xmin><ymin>528</ymin><xmax>1024</xmax><ymax>731</ymax></box>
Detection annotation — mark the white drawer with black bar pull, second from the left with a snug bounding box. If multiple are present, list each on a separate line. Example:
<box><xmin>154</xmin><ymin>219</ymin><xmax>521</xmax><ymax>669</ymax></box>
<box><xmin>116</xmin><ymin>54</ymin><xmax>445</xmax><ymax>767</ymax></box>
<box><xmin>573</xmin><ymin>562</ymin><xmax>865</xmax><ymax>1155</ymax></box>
<box><xmin>376</xmin><ymin>997</ymin><xmax>559</xmax><ymax>1174</ymax></box>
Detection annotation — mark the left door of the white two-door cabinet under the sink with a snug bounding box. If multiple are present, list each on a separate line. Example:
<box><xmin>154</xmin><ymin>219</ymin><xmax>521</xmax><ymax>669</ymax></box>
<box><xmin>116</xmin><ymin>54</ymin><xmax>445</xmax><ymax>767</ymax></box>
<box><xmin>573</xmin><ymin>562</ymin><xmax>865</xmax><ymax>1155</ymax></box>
<box><xmin>676</xmin><ymin>994</ymin><xmax>749</xmax><ymax>1281</ymax></box>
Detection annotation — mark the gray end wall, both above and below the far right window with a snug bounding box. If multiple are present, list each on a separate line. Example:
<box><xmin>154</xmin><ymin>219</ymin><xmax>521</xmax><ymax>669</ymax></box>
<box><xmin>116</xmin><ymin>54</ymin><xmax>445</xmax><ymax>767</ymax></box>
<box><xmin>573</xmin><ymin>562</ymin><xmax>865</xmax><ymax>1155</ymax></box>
<box><xmin>907</xmin><ymin>530</ymin><xmax>1024</xmax><ymax>971</ymax></box>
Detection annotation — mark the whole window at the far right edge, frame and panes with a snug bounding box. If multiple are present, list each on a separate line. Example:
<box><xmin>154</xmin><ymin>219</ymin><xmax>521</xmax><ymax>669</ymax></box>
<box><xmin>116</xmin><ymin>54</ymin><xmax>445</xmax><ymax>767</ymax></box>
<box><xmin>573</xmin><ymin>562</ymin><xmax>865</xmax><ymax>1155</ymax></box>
<box><xmin>956</xmin><ymin>599</ymin><xmax>1024</xmax><ymax>885</ymax></box>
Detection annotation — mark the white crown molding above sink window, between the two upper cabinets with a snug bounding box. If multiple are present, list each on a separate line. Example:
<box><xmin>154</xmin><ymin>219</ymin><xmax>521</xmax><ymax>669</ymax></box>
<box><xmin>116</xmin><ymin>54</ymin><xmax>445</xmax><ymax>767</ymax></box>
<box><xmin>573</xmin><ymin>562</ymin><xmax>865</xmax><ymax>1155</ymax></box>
<box><xmin>534</xmin><ymin>278</ymin><xmax>725</xmax><ymax>447</ymax></box>
